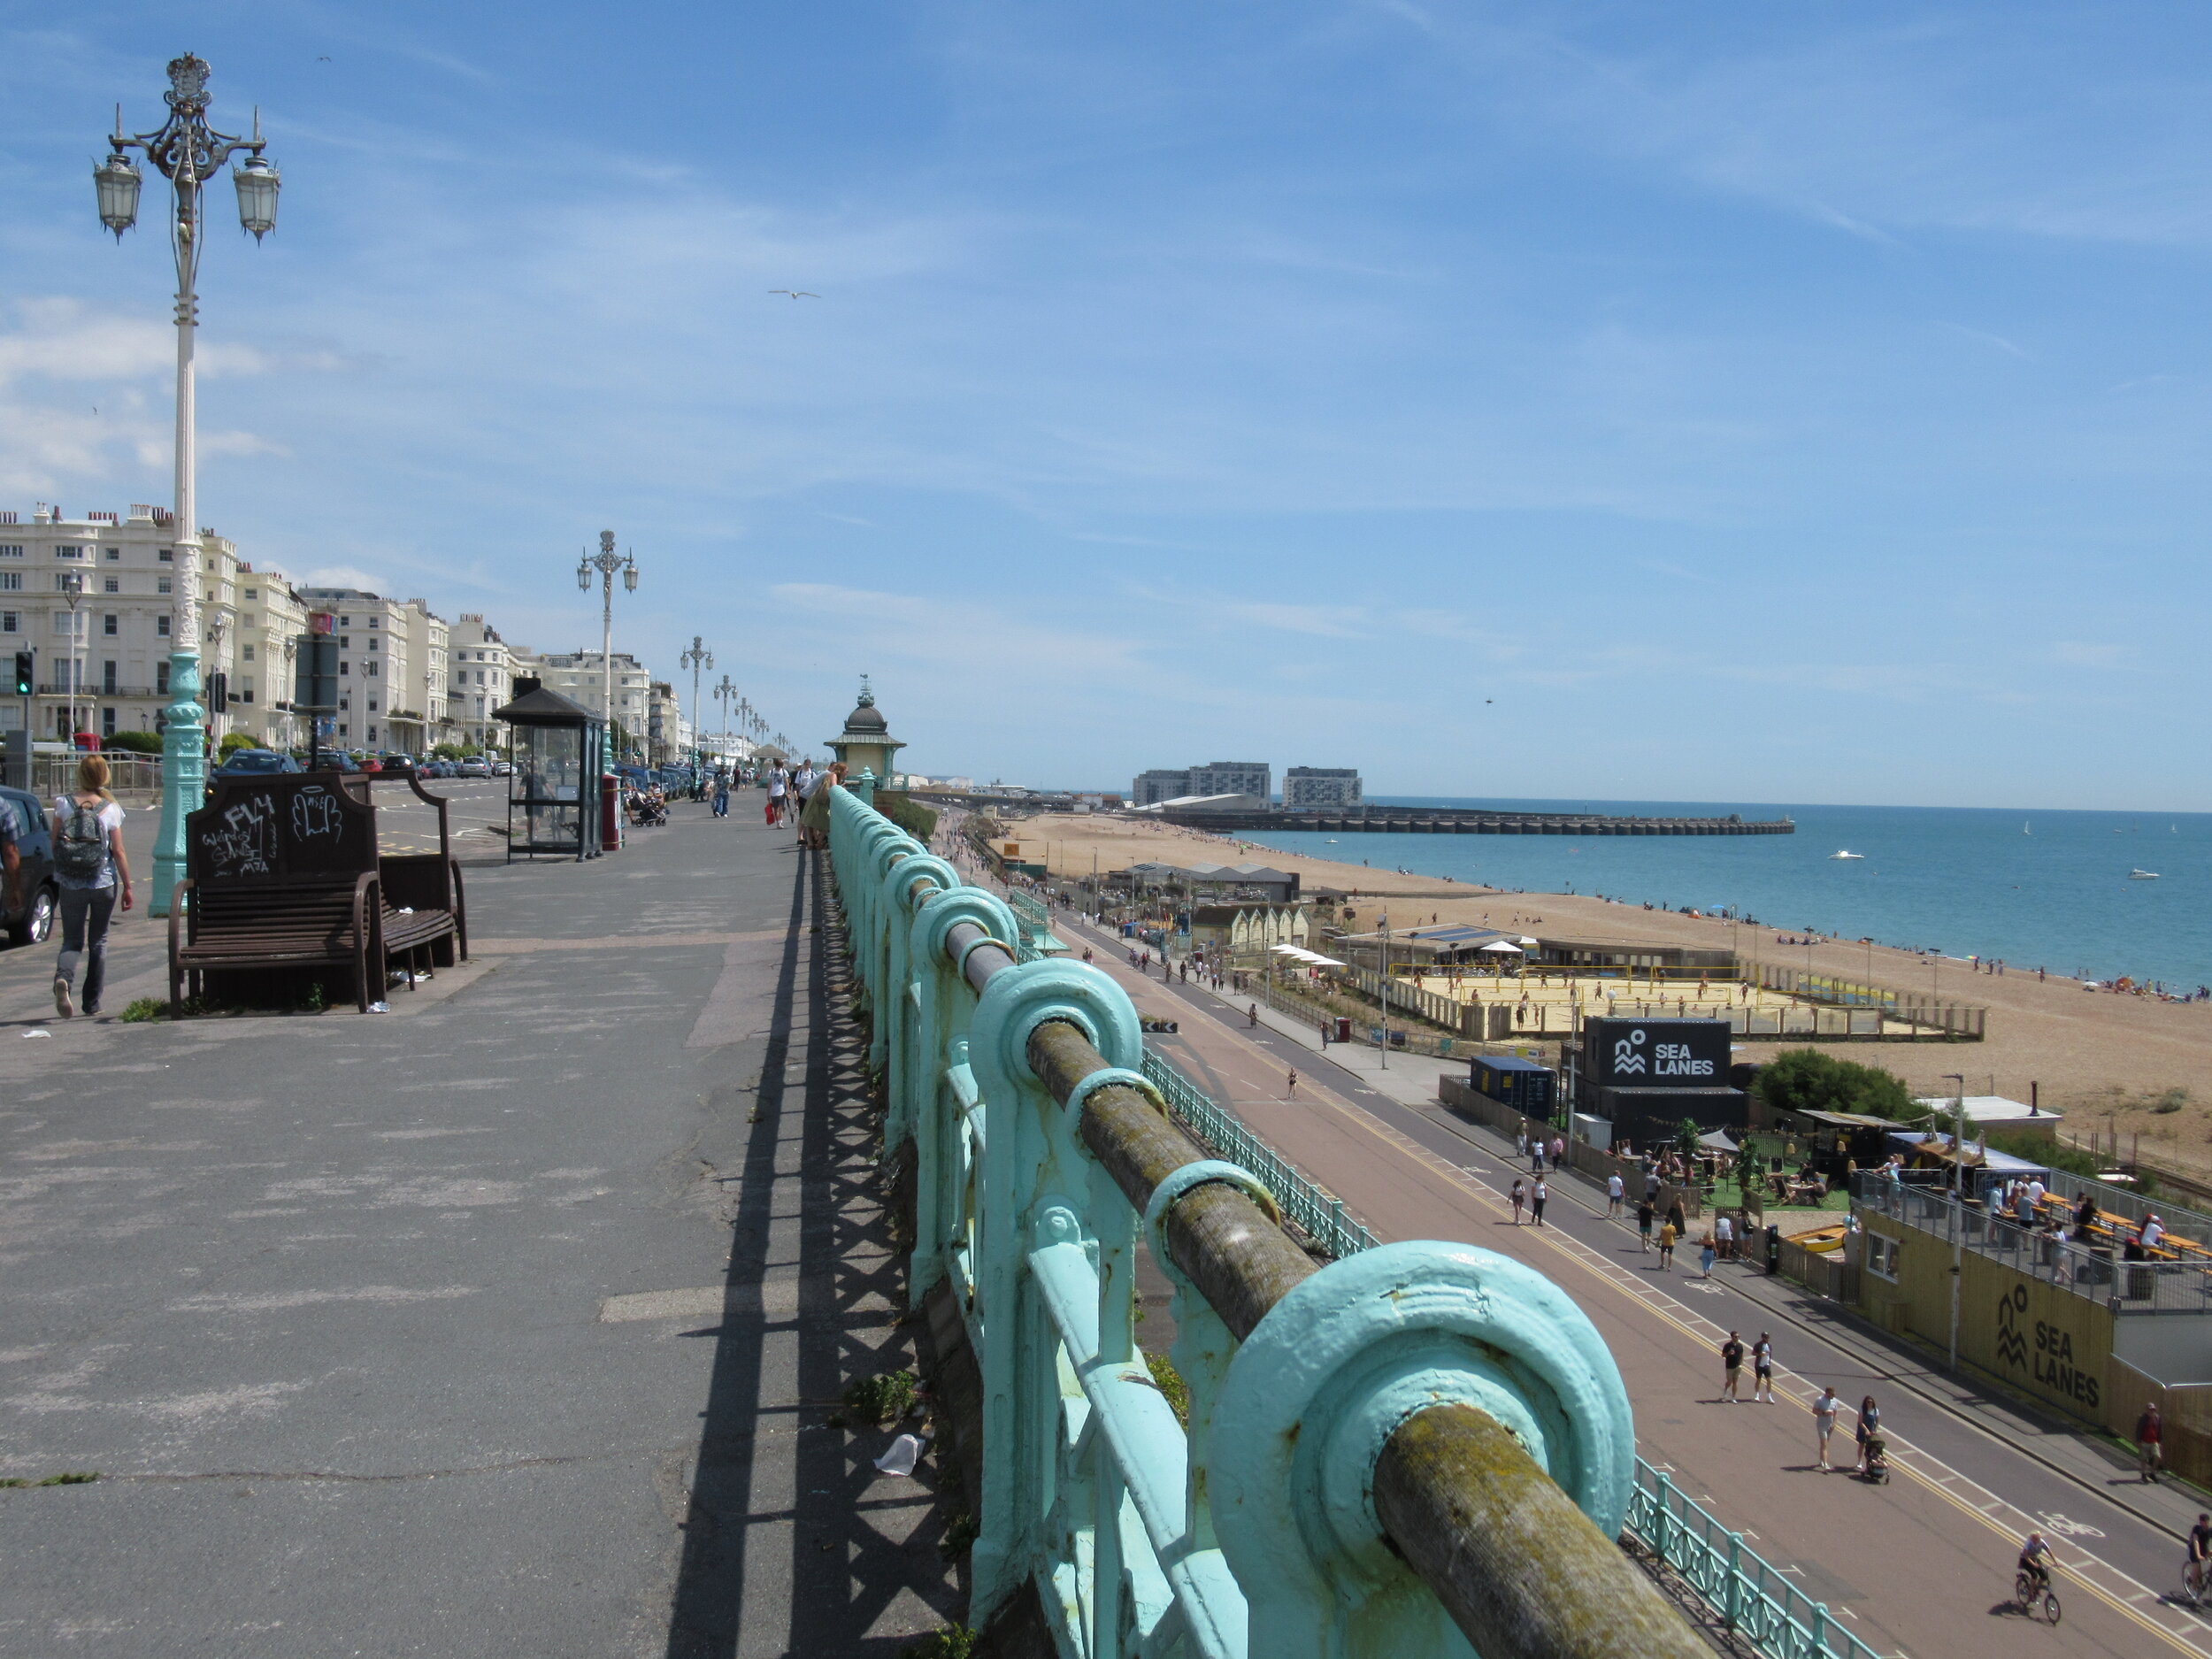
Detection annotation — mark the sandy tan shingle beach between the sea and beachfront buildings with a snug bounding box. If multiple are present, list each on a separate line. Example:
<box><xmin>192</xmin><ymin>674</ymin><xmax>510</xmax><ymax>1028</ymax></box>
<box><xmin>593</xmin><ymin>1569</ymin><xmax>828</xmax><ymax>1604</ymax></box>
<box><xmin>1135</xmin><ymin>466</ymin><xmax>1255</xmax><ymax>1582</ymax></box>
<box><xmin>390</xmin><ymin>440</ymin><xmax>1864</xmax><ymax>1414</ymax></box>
<box><xmin>1013</xmin><ymin>814</ymin><xmax>2212</xmax><ymax>1172</ymax></box>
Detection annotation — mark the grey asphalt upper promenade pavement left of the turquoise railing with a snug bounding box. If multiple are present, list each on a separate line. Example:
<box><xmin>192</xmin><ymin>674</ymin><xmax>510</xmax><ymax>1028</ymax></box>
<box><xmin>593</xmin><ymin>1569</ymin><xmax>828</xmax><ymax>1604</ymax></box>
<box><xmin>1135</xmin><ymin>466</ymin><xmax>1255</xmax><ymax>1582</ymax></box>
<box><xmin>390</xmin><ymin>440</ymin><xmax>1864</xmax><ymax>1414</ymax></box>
<box><xmin>0</xmin><ymin>805</ymin><xmax>958</xmax><ymax>1659</ymax></box>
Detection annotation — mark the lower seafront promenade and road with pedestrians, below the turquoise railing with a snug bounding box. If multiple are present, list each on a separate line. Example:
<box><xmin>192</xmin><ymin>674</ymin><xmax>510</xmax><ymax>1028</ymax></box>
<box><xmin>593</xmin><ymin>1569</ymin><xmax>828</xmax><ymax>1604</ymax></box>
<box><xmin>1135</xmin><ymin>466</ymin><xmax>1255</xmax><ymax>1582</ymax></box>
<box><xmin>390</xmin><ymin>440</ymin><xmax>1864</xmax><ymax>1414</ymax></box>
<box><xmin>1056</xmin><ymin>914</ymin><xmax>2212</xmax><ymax>1659</ymax></box>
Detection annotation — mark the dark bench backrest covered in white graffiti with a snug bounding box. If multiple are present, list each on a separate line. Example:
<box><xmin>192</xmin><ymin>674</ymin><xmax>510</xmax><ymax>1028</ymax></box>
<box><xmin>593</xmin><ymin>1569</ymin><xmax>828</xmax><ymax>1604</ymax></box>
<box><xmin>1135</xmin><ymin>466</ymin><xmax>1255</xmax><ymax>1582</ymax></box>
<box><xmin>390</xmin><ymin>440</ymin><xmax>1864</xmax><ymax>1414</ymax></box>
<box><xmin>184</xmin><ymin>772</ymin><xmax>376</xmax><ymax>894</ymax></box>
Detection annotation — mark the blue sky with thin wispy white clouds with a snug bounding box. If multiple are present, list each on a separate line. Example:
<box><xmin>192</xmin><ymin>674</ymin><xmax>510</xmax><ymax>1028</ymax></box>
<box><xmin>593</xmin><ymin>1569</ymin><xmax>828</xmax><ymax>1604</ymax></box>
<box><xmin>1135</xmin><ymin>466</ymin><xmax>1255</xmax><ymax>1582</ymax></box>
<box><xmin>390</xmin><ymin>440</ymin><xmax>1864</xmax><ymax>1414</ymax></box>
<box><xmin>0</xmin><ymin>0</ymin><xmax>2212</xmax><ymax>810</ymax></box>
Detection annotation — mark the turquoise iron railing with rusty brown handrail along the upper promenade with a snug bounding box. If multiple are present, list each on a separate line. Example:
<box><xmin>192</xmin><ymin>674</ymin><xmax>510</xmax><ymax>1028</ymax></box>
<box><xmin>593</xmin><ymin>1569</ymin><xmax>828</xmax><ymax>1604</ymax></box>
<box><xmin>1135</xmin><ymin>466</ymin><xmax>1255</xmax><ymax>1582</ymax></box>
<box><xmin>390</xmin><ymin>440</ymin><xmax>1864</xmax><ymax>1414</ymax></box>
<box><xmin>830</xmin><ymin>777</ymin><xmax>1703</xmax><ymax>1659</ymax></box>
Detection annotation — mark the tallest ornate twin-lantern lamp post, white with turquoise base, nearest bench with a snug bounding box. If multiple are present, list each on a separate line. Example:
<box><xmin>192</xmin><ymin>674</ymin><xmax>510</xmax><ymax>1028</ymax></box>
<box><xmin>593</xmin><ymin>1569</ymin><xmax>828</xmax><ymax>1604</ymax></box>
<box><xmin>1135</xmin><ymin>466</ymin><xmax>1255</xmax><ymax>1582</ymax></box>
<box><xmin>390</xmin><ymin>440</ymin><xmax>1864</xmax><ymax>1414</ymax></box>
<box><xmin>97</xmin><ymin>53</ymin><xmax>279</xmax><ymax>916</ymax></box>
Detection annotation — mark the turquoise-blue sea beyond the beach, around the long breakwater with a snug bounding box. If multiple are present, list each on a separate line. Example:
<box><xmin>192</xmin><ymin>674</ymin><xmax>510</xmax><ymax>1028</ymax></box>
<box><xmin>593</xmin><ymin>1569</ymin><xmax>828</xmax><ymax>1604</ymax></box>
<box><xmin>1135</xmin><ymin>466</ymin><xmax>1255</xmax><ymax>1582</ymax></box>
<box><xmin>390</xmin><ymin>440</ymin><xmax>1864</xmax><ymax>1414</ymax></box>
<box><xmin>1241</xmin><ymin>796</ymin><xmax>2212</xmax><ymax>991</ymax></box>
